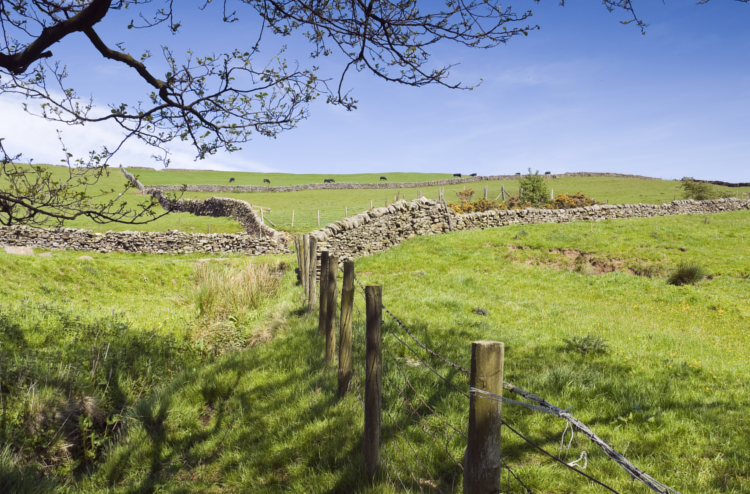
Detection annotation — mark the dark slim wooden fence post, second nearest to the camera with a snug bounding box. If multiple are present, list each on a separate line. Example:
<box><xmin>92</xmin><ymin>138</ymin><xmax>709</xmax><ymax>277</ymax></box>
<box><xmin>364</xmin><ymin>286</ymin><xmax>383</xmax><ymax>479</ymax></box>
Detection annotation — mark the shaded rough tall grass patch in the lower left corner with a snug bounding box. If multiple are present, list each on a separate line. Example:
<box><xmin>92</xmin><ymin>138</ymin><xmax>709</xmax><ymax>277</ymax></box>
<box><xmin>0</xmin><ymin>303</ymin><xmax>200</xmax><ymax>480</ymax></box>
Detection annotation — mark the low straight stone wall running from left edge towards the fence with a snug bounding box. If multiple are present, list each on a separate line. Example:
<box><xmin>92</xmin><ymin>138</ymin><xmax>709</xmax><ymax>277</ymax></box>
<box><xmin>0</xmin><ymin>226</ymin><xmax>289</xmax><ymax>255</ymax></box>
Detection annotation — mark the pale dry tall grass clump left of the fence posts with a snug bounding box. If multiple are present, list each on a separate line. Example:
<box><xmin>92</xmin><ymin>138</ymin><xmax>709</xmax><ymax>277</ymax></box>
<box><xmin>184</xmin><ymin>262</ymin><xmax>282</xmax><ymax>350</ymax></box>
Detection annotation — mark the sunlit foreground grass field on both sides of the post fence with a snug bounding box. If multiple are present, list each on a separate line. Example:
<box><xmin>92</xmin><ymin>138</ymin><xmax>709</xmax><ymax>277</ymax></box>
<box><xmin>0</xmin><ymin>212</ymin><xmax>750</xmax><ymax>494</ymax></box>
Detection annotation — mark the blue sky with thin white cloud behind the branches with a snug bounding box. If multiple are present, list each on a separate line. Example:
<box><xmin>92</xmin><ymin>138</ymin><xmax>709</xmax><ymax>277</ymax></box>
<box><xmin>0</xmin><ymin>0</ymin><xmax>750</xmax><ymax>181</ymax></box>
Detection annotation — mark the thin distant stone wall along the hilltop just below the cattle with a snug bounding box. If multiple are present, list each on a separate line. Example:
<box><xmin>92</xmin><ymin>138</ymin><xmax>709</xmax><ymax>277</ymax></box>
<box><xmin>135</xmin><ymin>172</ymin><xmax>661</xmax><ymax>194</ymax></box>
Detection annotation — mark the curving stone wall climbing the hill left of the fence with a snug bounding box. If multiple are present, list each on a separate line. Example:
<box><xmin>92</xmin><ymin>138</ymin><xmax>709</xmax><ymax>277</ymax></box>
<box><xmin>120</xmin><ymin>166</ymin><xmax>287</xmax><ymax>243</ymax></box>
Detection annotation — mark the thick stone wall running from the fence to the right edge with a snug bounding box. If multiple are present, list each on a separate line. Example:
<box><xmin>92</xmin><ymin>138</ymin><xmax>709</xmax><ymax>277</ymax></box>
<box><xmin>310</xmin><ymin>198</ymin><xmax>750</xmax><ymax>262</ymax></box>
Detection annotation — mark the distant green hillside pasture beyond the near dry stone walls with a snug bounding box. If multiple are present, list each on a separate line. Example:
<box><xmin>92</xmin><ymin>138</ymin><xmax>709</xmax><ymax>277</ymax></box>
<box><xmin>2</xmin><ymin>167</ymin><xmax>750</xmax><ymax>233</ymax></box>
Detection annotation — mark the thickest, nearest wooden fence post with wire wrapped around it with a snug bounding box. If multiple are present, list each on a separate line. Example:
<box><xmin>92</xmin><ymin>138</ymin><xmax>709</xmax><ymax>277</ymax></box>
<box><xmin>464</xmin><ymin>341</ymin><xmax>505</xmax><ymax>494</ymax></box>
